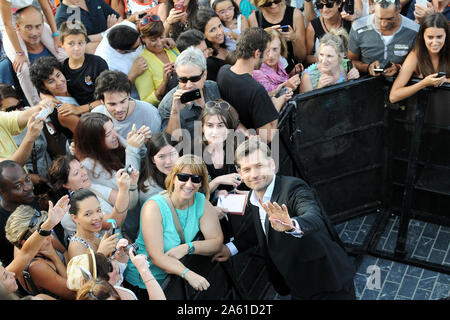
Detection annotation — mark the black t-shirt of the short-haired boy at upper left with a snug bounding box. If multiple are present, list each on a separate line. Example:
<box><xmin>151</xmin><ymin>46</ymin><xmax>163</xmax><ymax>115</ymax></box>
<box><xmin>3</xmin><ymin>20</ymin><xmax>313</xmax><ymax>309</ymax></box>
<box><xmin>62</xmin><ymin>53</ymin><xmax>108</xmax><ymax>105</ymax></box>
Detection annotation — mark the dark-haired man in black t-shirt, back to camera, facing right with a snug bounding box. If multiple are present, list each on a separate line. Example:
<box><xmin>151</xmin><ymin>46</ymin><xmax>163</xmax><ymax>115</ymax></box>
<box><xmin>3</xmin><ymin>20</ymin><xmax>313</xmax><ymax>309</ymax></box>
<box><xmin>217</xmin><ymin>27</ymin><xmax>292</xmax><ymax>143</ymax></box>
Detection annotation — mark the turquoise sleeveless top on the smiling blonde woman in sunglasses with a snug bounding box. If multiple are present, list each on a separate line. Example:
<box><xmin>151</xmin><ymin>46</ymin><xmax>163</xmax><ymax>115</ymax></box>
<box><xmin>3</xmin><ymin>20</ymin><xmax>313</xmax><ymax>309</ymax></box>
<box><xmin>125</xmin><ymin>192</ymin><xmax>205</xmax><ymax>289</ymax></box>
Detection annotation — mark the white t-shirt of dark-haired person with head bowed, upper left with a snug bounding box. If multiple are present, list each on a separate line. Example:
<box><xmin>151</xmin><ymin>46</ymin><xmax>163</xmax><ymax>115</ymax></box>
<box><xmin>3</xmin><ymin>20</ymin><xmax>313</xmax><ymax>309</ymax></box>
<box><xmin>95</xmin><ymin>20</ymin><xmax>143</xmax><ymax>74</ymax></box>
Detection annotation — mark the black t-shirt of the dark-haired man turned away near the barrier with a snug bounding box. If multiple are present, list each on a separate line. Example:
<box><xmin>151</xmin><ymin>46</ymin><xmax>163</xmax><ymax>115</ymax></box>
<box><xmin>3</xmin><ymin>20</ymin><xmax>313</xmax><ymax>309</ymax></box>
<box><xmin>217</xmin><ymin>65</ymin><xmax>279</xmax><ymax>129</ymax></box>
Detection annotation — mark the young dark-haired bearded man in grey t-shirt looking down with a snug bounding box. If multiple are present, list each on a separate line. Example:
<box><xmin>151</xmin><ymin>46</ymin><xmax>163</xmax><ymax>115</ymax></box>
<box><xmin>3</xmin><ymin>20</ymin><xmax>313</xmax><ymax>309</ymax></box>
<box><xmin>92</xmin><ymin>70</ymin><xmax>161</xmax><ymax>139</ymax></box>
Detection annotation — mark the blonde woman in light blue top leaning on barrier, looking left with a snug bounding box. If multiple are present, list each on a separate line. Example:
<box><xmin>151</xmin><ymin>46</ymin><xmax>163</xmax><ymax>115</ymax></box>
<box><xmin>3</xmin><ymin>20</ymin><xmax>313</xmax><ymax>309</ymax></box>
<box><xmin>300</xmin><ymin>28</ymin><xmax>359</xmax><ymax>93</ymax></box>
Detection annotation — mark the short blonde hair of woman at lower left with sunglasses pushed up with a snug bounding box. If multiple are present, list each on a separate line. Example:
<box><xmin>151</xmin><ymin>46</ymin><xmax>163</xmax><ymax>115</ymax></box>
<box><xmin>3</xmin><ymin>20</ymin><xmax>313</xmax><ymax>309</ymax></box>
<box><xmin>5</xmin><ymin>205</ymin><xmax>47</xmax><ymax>248</ymax></box>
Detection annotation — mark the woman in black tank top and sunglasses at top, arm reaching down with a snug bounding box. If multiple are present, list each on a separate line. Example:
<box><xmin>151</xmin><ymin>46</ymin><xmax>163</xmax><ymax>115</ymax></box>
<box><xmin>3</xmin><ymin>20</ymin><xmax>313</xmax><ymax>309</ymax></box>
<box><xmin>248</xmin><ymin>0</ymin><xmax>306</xmax><ymax>73</ymax></box>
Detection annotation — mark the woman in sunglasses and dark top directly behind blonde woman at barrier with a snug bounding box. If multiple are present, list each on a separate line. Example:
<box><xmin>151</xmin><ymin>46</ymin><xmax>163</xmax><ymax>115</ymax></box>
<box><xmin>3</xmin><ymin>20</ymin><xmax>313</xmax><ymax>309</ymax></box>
<box><xmin>306</xmin><ymin>0</ymin><xmax>352</xmax><ymax>64</ymax></box>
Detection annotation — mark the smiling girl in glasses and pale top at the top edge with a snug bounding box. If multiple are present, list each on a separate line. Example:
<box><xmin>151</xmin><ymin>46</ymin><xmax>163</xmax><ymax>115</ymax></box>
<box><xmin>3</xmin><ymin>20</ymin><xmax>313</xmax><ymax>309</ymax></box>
<box><xmin>212</xmin><ymin>0</ymin><xmax>248</xmax><ymax>51</ymax></box>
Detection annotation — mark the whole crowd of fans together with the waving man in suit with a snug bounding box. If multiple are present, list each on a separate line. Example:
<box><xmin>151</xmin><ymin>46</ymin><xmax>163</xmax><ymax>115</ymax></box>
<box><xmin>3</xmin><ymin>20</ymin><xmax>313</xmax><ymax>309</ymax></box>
<box><xmin>0</xmin><ymin>0</ymin><xmax>450</xmax><ymax>300</ymax></box>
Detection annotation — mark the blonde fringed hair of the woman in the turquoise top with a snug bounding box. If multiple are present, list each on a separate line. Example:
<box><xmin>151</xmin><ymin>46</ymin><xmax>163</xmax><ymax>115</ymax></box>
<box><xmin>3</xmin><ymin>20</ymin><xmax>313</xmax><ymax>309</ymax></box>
<box><xmin>165</xmin><ymin>154</ymin><xmax>209</xmax><ymax>199</ymax></box>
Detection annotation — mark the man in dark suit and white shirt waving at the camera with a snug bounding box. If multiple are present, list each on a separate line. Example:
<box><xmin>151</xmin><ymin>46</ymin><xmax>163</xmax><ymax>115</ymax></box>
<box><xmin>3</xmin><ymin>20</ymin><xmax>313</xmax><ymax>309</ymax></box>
<box><xmin>213</xmin><ymin>139</ymin><xmax>355</xmax><ymax>300</ymax></box>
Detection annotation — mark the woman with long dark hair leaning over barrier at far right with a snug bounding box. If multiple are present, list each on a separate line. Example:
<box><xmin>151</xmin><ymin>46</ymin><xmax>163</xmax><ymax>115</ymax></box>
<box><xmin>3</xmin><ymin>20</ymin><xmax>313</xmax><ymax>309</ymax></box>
<box><xmin>389</xmin><ymin>13</ymin><xmax>450</xmax><ymax>103</ymax></box>
